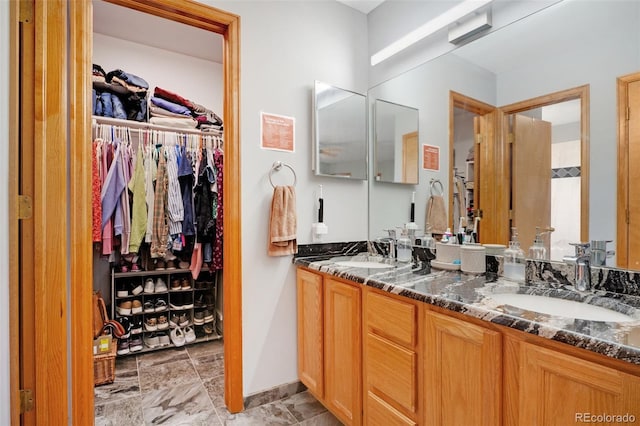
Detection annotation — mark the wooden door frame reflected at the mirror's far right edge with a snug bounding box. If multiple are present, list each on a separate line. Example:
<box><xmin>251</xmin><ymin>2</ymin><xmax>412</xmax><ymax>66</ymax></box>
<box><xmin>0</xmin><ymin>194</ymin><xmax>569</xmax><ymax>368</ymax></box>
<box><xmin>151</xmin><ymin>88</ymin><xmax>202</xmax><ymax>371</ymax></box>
<box><xmin>616</xmin><ymin>73</ymin><xmax>640</xmax><ymax>268</ymax></box>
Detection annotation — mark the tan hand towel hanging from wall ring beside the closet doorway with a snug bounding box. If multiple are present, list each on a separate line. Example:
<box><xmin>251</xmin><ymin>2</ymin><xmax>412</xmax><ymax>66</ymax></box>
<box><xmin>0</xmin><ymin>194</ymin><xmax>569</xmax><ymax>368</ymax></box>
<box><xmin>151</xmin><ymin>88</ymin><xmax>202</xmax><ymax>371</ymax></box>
<box><xmin>267</xmin><ymin>186</ymin><xmax>298</xmax><ymax>256</ymax></box>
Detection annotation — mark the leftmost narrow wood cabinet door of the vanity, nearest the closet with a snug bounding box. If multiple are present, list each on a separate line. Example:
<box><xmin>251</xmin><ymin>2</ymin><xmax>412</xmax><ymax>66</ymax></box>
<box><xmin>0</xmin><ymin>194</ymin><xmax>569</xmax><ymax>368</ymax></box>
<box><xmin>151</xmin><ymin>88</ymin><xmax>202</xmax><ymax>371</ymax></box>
<box><xmin>297</xmin><ymin>269</ymin><xmax>324</xmax><ymax>398</ymax></box>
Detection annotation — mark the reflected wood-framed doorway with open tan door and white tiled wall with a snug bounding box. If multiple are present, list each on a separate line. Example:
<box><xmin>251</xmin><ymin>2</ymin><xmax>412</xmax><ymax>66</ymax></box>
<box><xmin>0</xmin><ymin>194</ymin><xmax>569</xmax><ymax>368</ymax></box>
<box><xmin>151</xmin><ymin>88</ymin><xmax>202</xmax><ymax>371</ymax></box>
<box><xmin>500</xmin><ymin>85</ymin><xmax>589</xmax><ymax>260</ymax></box>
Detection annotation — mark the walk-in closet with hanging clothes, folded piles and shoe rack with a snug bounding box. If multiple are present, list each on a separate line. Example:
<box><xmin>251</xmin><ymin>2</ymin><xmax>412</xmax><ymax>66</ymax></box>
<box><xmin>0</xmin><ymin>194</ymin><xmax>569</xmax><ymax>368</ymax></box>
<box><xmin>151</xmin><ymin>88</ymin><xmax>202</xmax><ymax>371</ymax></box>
<box><xmin>87</xmin><ymin>0</ymin><xmax>224</xmax><ymax>372</ymax></box>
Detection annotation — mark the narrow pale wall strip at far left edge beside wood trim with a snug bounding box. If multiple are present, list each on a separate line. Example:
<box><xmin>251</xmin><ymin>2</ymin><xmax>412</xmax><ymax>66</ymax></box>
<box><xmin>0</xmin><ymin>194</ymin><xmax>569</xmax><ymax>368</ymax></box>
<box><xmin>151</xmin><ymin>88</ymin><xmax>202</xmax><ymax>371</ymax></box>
<box><xmin>0</xmin><ymin>1</ymin><xmax>10</xmax><ymax>425</ymax></box>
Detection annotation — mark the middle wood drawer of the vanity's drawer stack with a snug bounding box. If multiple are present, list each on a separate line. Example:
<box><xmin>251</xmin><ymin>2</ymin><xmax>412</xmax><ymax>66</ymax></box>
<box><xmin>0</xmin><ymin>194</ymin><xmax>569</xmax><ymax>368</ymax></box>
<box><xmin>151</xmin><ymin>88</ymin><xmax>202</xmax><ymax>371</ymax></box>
<box><xmin>365</xmin><ymin>333</ymin><xmax>418</xmax><ymax>413</ymax></box>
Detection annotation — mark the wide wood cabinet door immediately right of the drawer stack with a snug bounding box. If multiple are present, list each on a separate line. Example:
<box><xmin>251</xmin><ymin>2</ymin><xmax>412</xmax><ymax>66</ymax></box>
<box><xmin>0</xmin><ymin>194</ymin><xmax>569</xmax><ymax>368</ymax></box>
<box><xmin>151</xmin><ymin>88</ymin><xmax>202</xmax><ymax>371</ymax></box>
<box><xmin>423</xmin><ymin>311</ymin><xmax>502</xmax><ymax>426</ymax></box>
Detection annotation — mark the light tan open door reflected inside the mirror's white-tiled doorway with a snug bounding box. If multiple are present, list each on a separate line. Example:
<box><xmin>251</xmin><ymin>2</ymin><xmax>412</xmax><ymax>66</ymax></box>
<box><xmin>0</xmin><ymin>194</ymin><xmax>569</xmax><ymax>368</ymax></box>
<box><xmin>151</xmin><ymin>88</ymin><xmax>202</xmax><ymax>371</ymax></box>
<box><xmin>511</xmin><ymin>114</ymin><xmax>551</xmax><ymax>253</ymax></box>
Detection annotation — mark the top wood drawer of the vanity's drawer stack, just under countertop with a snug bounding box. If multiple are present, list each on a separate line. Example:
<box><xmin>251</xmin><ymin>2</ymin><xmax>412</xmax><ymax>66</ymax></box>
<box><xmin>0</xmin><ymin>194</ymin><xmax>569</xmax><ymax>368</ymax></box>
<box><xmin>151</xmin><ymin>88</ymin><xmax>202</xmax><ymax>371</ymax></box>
<box><xmin>365</xmin><ymin>291</ymin><xmax>418</xmax><ymax>348</ymax></box>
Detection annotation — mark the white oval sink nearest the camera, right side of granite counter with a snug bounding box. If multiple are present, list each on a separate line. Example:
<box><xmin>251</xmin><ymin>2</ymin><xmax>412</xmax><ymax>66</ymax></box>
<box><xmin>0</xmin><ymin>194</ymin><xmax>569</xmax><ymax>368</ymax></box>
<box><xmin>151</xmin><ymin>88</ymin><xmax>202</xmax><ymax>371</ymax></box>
<box><xmin>488</xmin><ymin>293</ymin><xmax>636</xmax><ymax>322</ymax></box>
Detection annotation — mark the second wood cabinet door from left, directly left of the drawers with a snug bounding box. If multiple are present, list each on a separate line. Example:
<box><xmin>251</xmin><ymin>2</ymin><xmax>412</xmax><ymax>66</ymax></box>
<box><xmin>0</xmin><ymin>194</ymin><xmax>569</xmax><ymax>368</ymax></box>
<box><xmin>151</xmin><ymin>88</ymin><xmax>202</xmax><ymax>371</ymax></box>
<box><xmin>324</xmin><ymin>277</ymin><xmax>362</xmax><ymax>425</ymax></box>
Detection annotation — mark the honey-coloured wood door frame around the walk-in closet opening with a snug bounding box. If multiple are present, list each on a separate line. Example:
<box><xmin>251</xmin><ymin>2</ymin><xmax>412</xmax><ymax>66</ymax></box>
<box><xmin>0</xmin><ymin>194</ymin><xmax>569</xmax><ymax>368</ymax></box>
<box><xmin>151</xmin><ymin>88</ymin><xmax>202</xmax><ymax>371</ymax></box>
<box><xmin>9</xmin><ymin>0</ymin><xmax>243</xmax><ymax>424</ymax></box>
